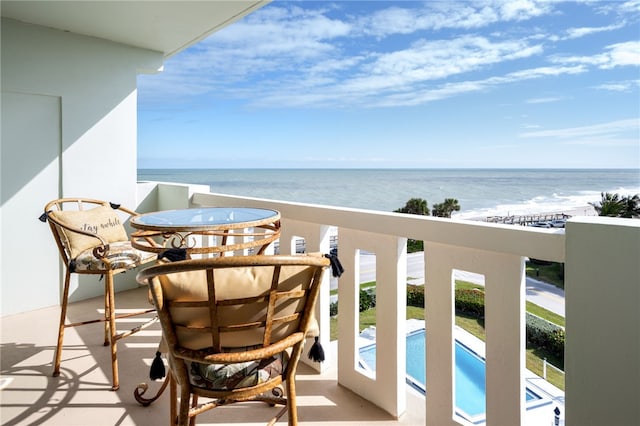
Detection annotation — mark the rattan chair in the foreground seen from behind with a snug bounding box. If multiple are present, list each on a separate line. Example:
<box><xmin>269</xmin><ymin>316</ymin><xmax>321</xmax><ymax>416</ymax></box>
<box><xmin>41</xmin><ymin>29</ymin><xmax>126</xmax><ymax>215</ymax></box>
<box><xmin>138</xmin><ymin>255</ymin><xmax>330</xmax><ymax>426</ymax></box>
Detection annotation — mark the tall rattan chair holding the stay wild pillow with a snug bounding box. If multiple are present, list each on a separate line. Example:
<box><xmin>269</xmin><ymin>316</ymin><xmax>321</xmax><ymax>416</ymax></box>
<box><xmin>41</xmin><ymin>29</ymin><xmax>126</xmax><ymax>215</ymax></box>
<box><xmin>40</xmin><ymin>198</ymin><xmax>156</xmax><ymax>390</ymax></box>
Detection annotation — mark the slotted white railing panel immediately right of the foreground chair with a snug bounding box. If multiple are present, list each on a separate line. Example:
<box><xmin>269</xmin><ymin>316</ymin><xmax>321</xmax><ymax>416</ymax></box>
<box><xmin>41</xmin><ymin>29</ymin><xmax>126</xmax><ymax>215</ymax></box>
<box><xmin>338</xmin><ymin>229</ymin><xmax>407</xmax><ymax>417</ymax></box>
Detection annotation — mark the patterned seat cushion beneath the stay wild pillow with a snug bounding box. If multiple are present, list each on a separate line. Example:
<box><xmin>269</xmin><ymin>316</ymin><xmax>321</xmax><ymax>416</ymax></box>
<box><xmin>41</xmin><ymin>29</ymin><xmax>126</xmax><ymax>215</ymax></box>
<box><xmin>75</xmin><ymin>241</ymin><xmax>155</xmax><ymax>271</ymax></box>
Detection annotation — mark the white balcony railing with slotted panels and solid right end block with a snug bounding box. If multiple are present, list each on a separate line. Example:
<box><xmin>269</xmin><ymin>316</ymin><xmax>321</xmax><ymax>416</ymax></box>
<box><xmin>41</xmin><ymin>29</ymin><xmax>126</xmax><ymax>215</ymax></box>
<box><xmin>139</xmin><ymin>183</ymin><xmax>640</xmax><ymax>425</ymax></box>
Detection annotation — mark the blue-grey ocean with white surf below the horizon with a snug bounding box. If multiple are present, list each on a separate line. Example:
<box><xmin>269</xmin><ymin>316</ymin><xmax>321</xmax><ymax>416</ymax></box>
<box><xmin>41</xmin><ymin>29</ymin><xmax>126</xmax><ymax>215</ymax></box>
<box><xmin>138</xmin><ymin>169</ymin><xmax>640</xmax><ymax>218</ymax></box>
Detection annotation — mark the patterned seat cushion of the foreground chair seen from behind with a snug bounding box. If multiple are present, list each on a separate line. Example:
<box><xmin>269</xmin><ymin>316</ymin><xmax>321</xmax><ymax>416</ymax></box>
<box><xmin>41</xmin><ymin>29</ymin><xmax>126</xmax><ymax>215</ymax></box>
<box><xmin>187</xmin><ymin>352</ymin><xmax>288</xmax><ymax>390</ymax></box>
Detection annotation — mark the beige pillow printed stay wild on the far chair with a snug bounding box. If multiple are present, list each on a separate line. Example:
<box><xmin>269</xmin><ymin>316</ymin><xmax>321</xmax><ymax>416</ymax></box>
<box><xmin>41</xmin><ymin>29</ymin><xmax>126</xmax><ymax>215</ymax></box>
<box><xmin>49</xmin><ymin>206</ymin><xmax>129</xmax><ymax>259</ymax></box>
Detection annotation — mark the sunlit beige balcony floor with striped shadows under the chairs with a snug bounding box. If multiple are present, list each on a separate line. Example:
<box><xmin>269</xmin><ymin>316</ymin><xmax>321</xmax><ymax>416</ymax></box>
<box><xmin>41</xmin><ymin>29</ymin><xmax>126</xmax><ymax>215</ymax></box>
<box><xmin>0</xmin><ymin>283</ymin><xmax>425</xmax><ymax>426</ymax></box>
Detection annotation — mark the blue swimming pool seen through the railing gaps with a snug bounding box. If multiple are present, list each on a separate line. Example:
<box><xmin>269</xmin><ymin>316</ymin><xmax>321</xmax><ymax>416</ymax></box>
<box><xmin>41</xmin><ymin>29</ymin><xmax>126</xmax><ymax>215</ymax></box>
<box><xmin>360</xmin><ymin>329</ymin><xmax>541</xmax><ymax>421</ymax></box>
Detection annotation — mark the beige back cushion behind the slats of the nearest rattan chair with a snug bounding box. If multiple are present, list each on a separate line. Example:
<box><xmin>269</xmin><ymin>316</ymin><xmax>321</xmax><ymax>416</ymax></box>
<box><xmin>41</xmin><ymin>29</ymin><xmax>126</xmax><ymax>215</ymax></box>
<box><xmin>160</xmin><ymin>266</ymin><xmax>317</xmax><ymax>349</ymax></box>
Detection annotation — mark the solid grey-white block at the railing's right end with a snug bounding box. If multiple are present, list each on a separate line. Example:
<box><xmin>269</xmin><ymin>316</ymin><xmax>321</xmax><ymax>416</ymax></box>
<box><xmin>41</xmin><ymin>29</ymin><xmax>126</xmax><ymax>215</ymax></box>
<box><xmin>564</xmin><ymin>217</ymin><xmax>640</xmax><ymax>425</ymax></box>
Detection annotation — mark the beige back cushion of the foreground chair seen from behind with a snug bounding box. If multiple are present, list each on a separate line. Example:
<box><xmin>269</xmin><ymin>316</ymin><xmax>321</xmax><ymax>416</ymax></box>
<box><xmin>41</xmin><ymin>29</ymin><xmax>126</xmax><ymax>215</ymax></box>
<box><xmin>159</xmin><ymin>265</ymin><xmax>315</xmax><ymax>351</ymax></box>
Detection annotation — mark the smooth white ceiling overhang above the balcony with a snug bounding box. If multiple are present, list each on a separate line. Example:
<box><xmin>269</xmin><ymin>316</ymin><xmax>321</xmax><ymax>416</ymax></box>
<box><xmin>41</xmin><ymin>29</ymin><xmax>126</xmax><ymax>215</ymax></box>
<box><xmin>0</xmin><ymin>0</ymin><xmax>269</xmax><ymax>57</ymax></box>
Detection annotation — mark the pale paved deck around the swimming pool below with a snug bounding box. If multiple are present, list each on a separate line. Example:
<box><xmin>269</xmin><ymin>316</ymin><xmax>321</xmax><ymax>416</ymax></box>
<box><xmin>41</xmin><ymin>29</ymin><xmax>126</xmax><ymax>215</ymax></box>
<box><xmin>359</xmin><ymin>319</ymin><xmax>564</xmax><ymax>426</ymax></box>
